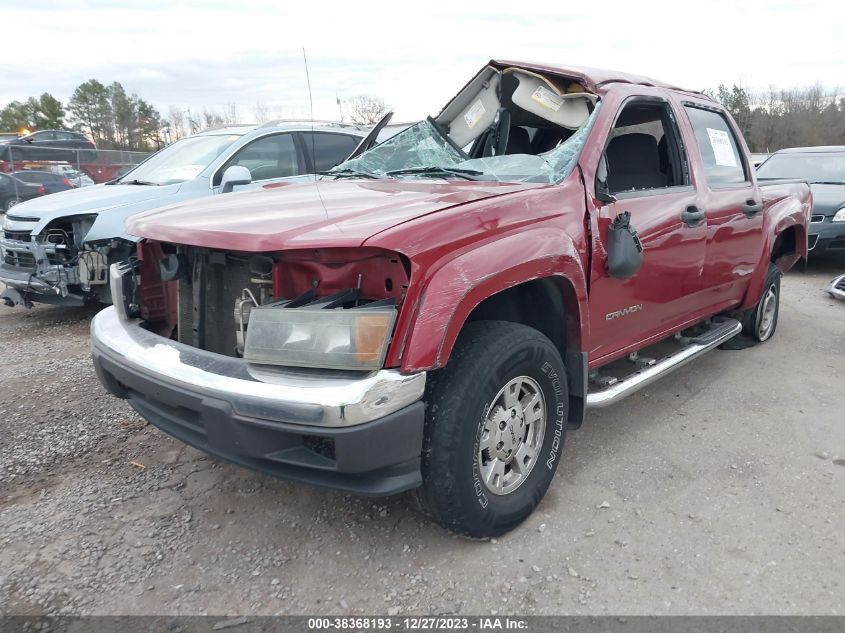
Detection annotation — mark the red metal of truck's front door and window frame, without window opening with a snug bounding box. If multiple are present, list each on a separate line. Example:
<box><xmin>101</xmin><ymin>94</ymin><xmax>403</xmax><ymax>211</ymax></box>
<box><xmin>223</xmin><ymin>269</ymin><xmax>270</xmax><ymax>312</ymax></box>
<box><xmin>579</xmin><ymin>86</ymin><xmax>707</xmax><ymax>367</ymax></box>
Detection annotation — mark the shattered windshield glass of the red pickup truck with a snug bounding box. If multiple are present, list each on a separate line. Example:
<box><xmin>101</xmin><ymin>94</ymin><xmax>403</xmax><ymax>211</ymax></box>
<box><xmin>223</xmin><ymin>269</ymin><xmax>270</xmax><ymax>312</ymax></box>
<box><xmin>328</xmin><ymin>105</ymin><xmax>599</xmax><ymax>183</ymax></box>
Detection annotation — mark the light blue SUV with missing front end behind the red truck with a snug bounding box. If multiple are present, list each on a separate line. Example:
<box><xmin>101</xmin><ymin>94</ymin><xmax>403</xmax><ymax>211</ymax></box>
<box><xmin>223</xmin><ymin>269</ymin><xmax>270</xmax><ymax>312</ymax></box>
<box><xmin>0</xmin><ymin>122</ymin><xmax>366</xmax><ymax>307</ymax></box>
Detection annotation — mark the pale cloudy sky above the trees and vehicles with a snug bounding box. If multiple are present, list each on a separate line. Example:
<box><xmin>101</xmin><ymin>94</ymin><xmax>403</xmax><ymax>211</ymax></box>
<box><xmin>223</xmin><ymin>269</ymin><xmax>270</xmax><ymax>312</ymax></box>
<box><xmin>0</xmin><ymin>0</ymin><xmax>845</xmax><ymax>121</ymax></box>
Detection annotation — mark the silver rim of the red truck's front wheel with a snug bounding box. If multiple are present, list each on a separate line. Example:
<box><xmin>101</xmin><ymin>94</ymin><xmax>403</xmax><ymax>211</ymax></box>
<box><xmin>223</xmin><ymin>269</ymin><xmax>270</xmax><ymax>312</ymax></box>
<box><xmin>477</xmin><ymin>376</ymin><xmax>546</xmax><ymax>495</ymax></box>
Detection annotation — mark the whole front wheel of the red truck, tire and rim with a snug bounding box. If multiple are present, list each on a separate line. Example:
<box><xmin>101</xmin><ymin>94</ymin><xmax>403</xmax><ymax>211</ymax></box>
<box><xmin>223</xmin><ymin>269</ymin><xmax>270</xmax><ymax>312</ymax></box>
<box><xmin>415</xmin><ymin>321</ymin><xmax>569</xmax><ymax>538</ymax></box>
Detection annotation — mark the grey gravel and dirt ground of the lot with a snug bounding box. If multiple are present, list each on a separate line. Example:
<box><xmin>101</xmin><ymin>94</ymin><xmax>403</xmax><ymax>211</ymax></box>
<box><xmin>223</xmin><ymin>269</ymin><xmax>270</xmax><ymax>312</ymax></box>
<box><xmin>0</xmin><ymin>266</ymin><xmax>845</xmax><ymax>614</ymax></box>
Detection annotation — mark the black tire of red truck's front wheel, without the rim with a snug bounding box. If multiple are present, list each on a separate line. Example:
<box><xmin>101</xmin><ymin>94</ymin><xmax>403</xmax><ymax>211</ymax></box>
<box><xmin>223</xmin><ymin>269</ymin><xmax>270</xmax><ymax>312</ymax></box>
<box><xmin>412</xmin><ymin>321</ymin><xmax>569</xmax><ymax>538</ymax></box>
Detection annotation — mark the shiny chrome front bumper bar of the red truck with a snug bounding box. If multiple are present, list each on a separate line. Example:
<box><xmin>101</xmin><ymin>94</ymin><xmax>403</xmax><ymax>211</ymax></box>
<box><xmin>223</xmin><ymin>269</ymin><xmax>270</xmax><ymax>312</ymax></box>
<box><xmin>91</xmin><ymin>307</ymin><xmax>426</xmax><ymax>428</ymax></box>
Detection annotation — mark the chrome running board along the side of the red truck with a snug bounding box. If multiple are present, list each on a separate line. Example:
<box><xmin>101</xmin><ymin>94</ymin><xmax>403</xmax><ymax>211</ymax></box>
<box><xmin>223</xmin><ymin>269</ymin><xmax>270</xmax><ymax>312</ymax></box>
<box><xmin>587</xmin><ymin>318</ymin><xmax>742</xmax><ymax>409</ymax></box>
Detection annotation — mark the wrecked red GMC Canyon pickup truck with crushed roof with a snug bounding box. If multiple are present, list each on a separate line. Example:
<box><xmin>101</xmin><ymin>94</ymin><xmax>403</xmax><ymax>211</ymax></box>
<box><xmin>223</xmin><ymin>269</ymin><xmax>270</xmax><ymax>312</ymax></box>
<box><xmin>91</xmin><ymin>61</ymin><xmax>811</xmax><ymax>537</ymax></box>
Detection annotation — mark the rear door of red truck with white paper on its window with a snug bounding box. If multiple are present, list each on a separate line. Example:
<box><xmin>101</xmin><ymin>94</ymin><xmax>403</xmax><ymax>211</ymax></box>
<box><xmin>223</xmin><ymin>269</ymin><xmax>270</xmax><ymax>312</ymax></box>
<box><xmin>681</xmin><ymin>101</ymin><xmax>763</xmax><ymax>312</ymax></box>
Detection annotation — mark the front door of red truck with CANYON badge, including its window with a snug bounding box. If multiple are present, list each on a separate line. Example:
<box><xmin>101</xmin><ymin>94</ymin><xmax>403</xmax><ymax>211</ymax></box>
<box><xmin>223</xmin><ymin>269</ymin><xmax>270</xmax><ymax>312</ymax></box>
<box><xmin>584</xmin><ymin>97</ymin><xmax>707</xmax><ymax>365</ymax></box>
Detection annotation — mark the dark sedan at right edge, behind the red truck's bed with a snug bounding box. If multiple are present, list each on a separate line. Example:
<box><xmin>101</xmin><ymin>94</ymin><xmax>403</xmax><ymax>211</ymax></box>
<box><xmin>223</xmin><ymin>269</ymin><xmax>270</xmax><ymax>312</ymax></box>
<box><xmin>757</xmin><ymin>145</ymin><xmax>845</xmax><ymax>257</ymax></box>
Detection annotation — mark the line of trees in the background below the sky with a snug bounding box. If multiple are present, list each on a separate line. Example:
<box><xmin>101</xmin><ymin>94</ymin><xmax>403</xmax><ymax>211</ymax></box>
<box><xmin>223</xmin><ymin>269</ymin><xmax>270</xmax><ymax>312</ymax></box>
<box><xmin>6</xmin><ymin>79</ymin><xmax>845</xmax><ymax>152</ymax></box>
